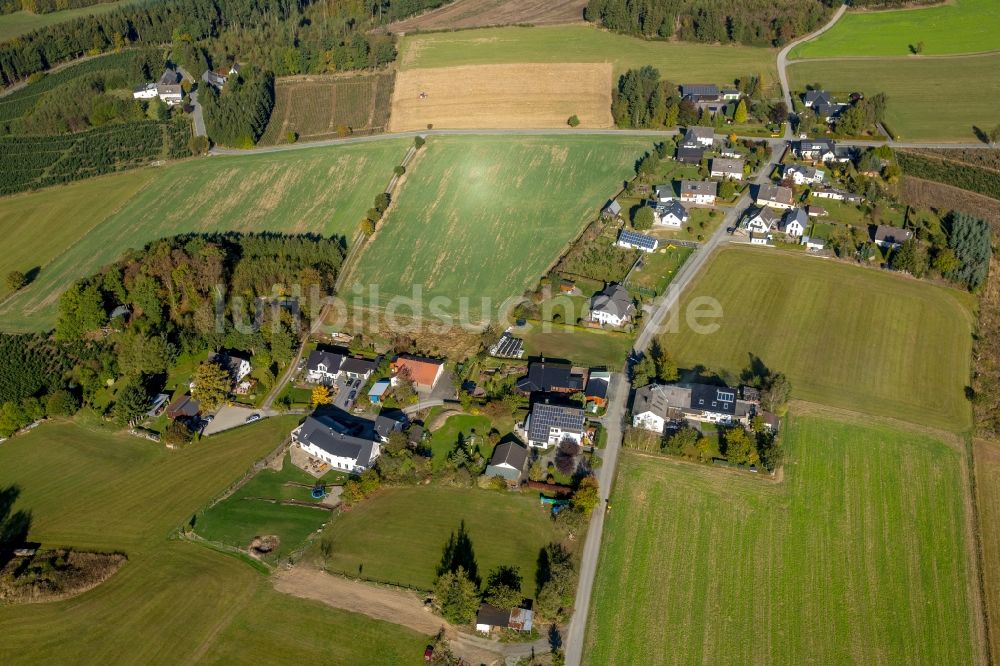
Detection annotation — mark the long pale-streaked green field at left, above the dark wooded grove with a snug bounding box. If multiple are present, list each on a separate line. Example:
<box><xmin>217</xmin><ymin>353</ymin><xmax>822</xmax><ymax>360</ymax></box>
<box><xmin>0</xmin><ymin>139</ymin><xmax>409</xmax><ymax>331</ymax></box>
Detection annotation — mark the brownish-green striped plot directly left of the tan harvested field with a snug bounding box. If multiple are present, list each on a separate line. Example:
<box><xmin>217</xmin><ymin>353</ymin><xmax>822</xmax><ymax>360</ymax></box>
<box><xmin>260</xmin><ymin>72</ymin><xmax>394</xmax><ymax>146</ymax></box>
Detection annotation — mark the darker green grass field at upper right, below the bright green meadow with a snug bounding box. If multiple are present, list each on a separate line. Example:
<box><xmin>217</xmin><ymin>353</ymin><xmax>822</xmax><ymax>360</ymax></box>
<box><xmin>788</xmin><ymin>53</ymin><xmax>1000</xmax><ymax>142</ymax></box>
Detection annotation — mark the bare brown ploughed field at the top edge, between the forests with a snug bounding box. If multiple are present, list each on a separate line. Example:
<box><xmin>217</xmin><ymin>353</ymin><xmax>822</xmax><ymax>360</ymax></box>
<box><xmin>389</xmin><ymin>0</ymin><xmax>587</xmax><ymax>33</ymax></box>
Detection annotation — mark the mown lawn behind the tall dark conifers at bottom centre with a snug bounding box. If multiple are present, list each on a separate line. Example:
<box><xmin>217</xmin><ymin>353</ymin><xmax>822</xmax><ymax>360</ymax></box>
<box><xmin>323</xmin><ymin>485</ymin><xmax>555</xmax><ymax>596</ymax></box>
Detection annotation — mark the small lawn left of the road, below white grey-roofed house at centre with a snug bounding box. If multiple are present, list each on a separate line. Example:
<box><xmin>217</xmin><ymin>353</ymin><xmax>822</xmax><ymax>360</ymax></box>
<box><xmin>512</xmin><ymin>322</ymin><xmax>634</xmax><ymax>370</ymax></box>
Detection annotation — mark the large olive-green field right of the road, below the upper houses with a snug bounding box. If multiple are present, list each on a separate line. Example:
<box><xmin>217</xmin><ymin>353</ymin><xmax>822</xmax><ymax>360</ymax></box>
<box><xmin>665</xmin><ymin>248</ymin><xmax>972</xmax><ymax>430</ymax></box>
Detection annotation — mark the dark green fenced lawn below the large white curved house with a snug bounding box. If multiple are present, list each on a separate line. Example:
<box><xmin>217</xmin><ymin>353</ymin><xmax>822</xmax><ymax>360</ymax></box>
<box><xmin>195</xmin><ymin>455</ymin><xmax>340</xmax><ymax>564</ymax></box>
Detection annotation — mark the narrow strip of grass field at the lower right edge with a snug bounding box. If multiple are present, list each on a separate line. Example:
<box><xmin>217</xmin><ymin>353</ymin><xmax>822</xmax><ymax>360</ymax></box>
<box><xmin>973</xmin><ymin>440</ymin><xmax>1000</xmax><ymax>663</ymax></box>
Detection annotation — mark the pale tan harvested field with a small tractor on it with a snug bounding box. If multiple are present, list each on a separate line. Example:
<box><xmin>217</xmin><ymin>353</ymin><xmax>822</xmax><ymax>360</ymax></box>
<box><xmin>390</xmin><ymin>63</ymin><xmax>612</xmax><ymax>132</ymax></box>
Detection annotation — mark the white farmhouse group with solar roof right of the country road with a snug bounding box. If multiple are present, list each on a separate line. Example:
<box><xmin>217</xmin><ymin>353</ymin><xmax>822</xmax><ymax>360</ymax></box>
<box><xmin>632</xmin><ymin>383</ymin><xmax>777</xmax><ymax>435</ymax></box>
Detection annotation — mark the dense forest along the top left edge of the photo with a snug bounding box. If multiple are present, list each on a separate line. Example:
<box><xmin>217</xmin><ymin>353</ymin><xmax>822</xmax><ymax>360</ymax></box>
<box><xmin>0</xmin><ymin>0</ymin><xmax>443</xmax><ymax>85</ymax></box>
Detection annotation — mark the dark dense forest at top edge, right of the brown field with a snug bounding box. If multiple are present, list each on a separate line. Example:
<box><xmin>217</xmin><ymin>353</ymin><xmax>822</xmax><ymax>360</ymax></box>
<box><xmin>584</xmin><ymin>0</ymin><xmax>841</xmax><ymax>46</ymax></box>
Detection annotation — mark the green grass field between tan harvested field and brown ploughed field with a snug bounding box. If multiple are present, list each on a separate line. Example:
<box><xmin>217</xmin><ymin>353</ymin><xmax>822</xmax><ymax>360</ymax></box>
<box><xmin>399</xmin><ymin>25</ymin><xmax>777</xmax><ymax>87</ymax></box>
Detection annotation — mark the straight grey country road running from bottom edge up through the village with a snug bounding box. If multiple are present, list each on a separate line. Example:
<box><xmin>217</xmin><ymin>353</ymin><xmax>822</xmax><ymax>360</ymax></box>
<box><xmin>564</xmin><ymin>141</ymin><xmax>785</xmax><ymax>666</ymax></box>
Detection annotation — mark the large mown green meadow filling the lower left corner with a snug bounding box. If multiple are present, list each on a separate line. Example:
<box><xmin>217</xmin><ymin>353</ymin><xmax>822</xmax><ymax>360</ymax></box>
<box><xmin>0</xmin><ymin>417</ymin><xmax>426</xmax><ymax>664</ymax></box>
